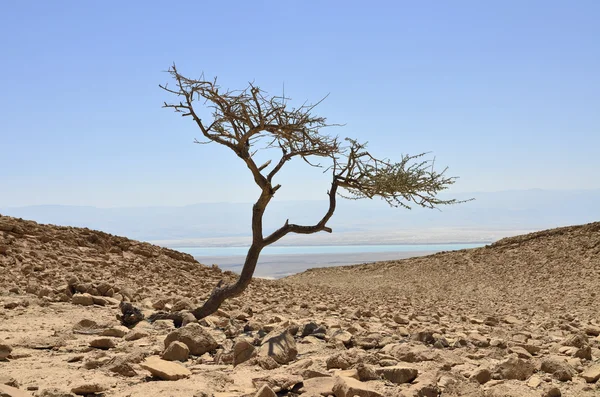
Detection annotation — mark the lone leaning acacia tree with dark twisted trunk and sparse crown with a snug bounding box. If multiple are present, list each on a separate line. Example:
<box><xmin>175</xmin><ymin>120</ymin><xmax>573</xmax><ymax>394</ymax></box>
<box><xmin>154</xmin><ymin>65</ymin><xmax>458</xmax><ymax>319</ymax></box>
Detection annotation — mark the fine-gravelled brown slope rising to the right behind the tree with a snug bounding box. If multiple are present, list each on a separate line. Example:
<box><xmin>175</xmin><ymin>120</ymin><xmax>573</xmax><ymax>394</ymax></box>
<box><xmin>287</xmin><ymin>222</ymin><xmax>600</xmax><ymax>318</ymax></box>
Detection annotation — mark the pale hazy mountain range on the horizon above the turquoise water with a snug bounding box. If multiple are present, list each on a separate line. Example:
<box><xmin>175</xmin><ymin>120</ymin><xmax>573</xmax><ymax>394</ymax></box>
<box><xmin>0</xmin><ymin>189</ymin><xmax>600</xmax><ymax>246</ymax></box>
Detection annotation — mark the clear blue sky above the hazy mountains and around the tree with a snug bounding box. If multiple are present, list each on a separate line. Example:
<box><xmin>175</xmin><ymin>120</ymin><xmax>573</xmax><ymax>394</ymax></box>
<box><xmin>0</xmin><ymin>0</ymin><xmax>600</xmax><ymax>207</ymax></box>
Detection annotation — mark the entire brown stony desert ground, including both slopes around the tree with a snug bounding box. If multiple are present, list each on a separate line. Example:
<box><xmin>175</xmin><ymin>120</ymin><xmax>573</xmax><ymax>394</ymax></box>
<box><xmin>0</xmin><ymin>216</ymin><xmax>600</xmax><ymax>397</ymax></box>
